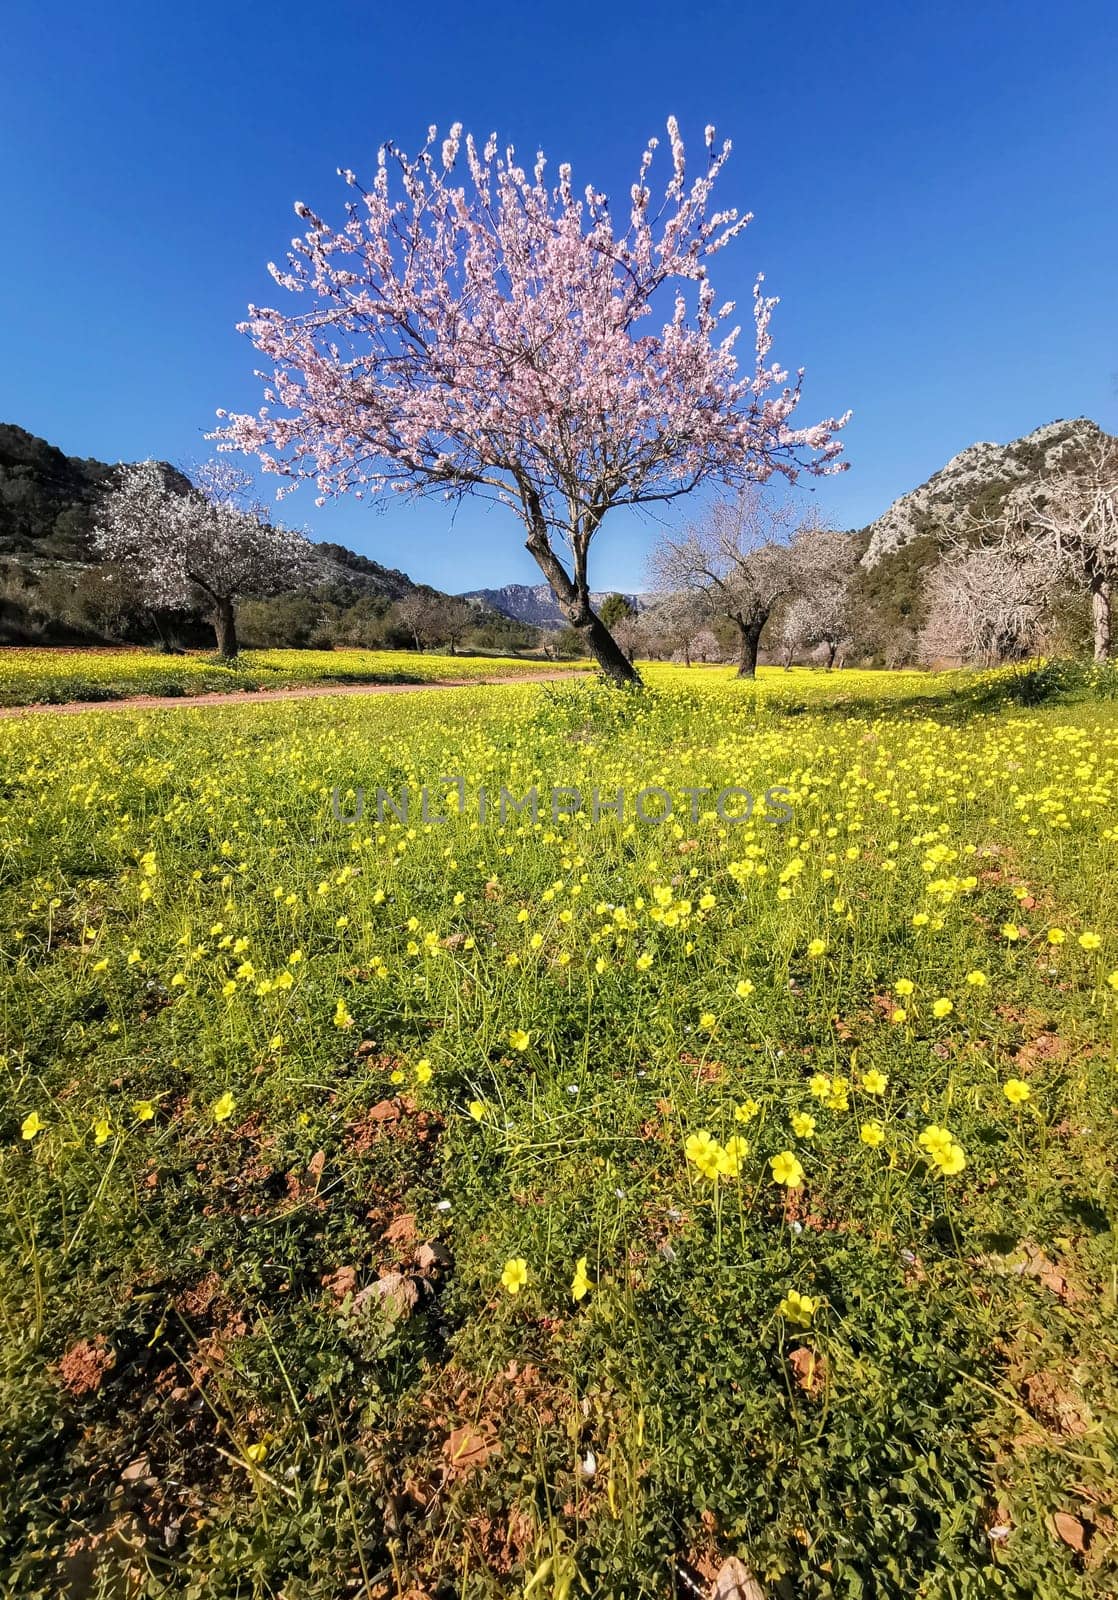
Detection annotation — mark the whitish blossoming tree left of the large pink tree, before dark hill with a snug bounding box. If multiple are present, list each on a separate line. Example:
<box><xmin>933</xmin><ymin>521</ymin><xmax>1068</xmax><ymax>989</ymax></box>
<box><xmin>94</xmin><ymin>461</ymin><xmax>310</xmax><ymax>659</ymax></box>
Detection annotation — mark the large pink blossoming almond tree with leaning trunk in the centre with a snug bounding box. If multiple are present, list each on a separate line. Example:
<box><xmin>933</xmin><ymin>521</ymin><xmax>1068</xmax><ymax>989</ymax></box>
<box><xmin>218</xmin><ymin>118</ymin><xmax>844</xmax><ymax>683</ymax></box>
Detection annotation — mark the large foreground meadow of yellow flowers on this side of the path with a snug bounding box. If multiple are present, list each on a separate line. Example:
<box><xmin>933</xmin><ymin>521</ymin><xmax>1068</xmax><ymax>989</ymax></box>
<box><xmin>0</xmin><ymin>658</ymin><xmax>1118</xmax><ymax>1600</ymax></box>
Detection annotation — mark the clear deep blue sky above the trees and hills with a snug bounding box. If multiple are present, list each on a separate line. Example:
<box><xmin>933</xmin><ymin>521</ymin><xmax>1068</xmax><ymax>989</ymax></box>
<box><xmin>0</xmin><ymin>0</ymin><xmax>1118</xmax><ymax>589</ymax></box>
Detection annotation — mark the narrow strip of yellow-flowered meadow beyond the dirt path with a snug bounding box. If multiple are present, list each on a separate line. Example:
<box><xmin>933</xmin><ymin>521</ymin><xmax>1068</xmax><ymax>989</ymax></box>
<box><xmin>0</xmin><ymin>650</ymin><xmax>585</xmax><ymax>706</ymax></box>
